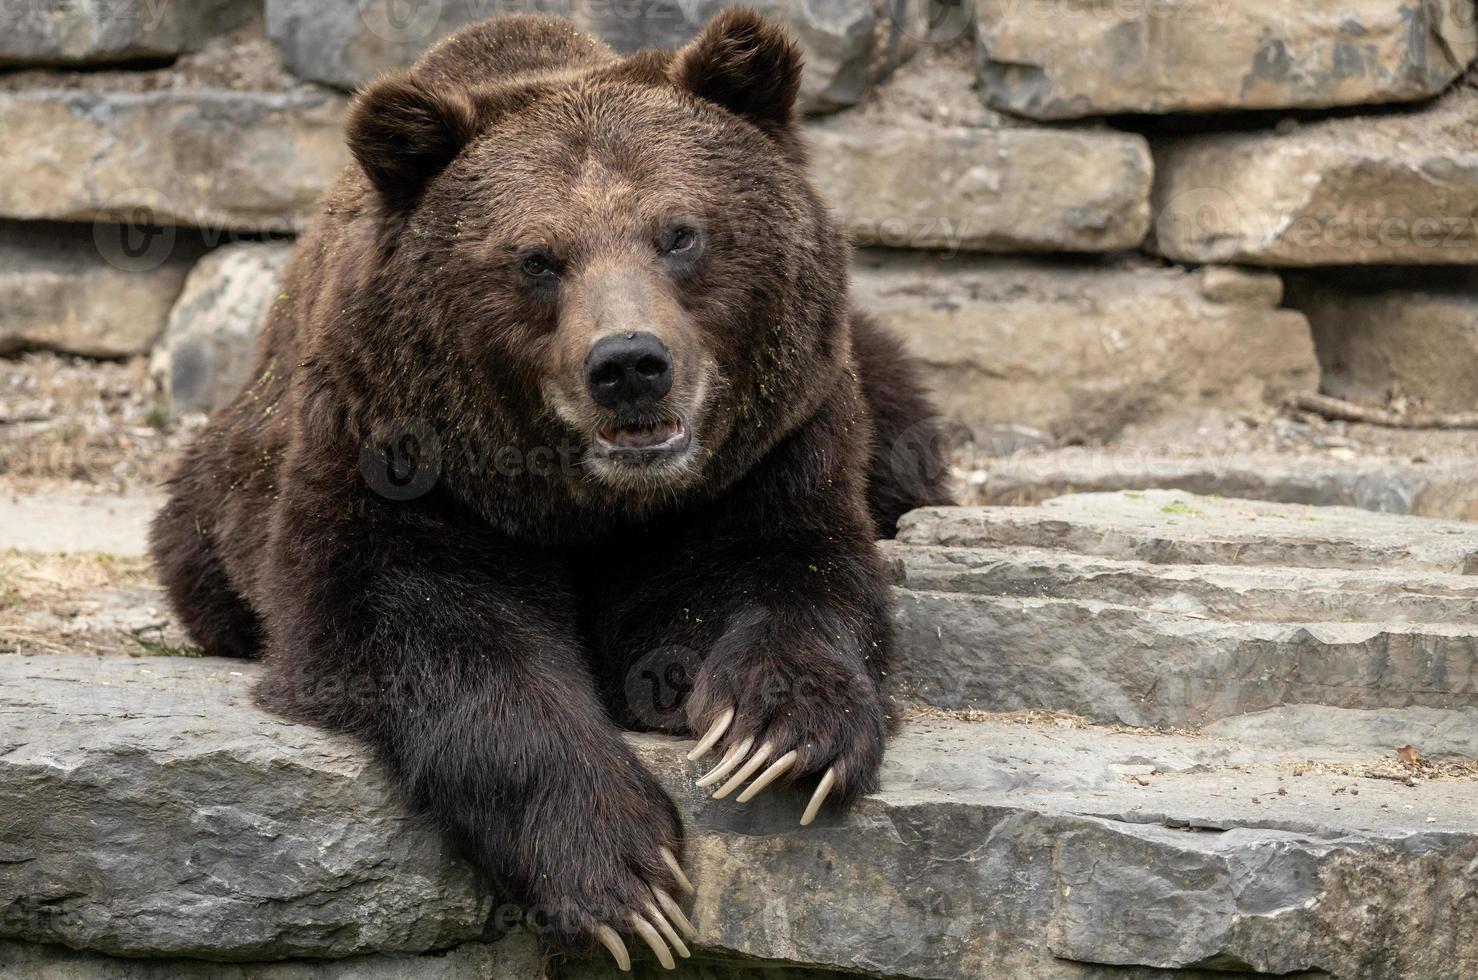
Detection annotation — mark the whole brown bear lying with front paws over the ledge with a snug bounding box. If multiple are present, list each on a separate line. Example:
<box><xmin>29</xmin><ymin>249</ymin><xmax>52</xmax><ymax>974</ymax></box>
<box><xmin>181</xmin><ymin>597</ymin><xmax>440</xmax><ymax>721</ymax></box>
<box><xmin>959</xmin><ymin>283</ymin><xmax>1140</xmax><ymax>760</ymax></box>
<box><xmin>152</xmin><ymin>10</ymin><xmax>946</xmax><ymax>967</ymax></box>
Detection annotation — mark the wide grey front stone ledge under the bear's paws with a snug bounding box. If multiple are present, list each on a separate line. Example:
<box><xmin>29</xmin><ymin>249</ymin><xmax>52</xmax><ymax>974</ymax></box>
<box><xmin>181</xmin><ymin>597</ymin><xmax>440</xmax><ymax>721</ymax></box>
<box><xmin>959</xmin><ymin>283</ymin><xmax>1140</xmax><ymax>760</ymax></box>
<box><xmin>0</xmin><ymin>656</ymin><xmax>1478</xmax><ymax>980</ymax></box>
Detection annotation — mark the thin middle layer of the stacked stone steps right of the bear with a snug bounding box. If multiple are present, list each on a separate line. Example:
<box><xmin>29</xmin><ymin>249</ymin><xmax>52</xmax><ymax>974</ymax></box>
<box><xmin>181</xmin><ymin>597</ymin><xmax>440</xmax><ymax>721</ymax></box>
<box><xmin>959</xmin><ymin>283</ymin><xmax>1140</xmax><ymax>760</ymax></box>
<box><xmin>881</xmin><ymin>541</ymin><xmax>1478</xmax><ymax>624</ymax></box>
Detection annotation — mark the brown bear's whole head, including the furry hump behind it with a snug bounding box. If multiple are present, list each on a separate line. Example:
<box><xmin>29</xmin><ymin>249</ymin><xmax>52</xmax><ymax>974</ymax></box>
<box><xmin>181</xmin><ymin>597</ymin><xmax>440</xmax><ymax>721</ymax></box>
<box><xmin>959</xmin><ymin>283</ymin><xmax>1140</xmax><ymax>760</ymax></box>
<box><xmin>335</xmin><ymin>10</ymin><xmax>850</xmax><ymax>532</ymax></box>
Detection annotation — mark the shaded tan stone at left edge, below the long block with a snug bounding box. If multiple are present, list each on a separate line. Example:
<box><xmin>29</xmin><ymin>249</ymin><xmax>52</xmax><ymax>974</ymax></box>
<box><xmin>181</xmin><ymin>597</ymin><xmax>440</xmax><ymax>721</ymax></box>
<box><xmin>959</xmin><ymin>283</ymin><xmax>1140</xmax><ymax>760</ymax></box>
<box><xmin>0</xmin><ymin>220</ymin><xmax>201</xmax><ymax>358</ymax></box>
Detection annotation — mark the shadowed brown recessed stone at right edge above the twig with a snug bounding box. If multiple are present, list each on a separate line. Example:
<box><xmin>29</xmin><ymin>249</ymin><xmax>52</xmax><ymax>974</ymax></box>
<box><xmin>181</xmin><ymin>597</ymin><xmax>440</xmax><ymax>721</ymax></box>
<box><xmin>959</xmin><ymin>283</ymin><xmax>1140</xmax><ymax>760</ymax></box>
<box><xmin>1289</xmin><ymin>266</ymin><xmax>1478</xmax><ymax>412</ymax></box>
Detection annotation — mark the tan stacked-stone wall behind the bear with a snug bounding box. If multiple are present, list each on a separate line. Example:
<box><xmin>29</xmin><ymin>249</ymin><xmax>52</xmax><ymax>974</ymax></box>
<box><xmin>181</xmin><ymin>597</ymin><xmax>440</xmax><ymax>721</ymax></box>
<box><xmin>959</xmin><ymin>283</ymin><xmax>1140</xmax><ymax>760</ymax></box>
<box><xmin>0</xmin><ymin>0</ymin><xmax>1478</xmax><ymax>443</ymax></box>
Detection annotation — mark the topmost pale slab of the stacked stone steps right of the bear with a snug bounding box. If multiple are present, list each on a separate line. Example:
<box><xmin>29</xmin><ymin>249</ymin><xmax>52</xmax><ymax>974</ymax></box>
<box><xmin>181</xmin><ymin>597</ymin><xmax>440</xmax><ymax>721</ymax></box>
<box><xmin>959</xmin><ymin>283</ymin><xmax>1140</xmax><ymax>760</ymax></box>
<box><xmin>899</xmin><ymin>491</ymin><xmax>1478</xmax><ymax>575</ymax></box>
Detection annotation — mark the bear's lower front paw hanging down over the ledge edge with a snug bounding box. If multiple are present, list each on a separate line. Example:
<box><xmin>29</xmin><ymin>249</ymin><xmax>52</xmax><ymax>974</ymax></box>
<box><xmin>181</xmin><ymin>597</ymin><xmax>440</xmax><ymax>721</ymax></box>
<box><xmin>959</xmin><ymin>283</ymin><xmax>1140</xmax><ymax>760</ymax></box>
<box><xmin>517</xmin><ymin>780</ymin><xmax>696</xmax><ymax>970</ymax></box>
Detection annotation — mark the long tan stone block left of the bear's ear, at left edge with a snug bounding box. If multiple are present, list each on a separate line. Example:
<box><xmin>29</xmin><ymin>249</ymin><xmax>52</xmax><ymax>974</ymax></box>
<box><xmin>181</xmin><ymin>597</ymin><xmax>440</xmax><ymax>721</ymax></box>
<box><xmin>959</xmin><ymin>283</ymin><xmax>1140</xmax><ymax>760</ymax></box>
<box><xmin>0</xmin><ymin>71</ymin><xmax>349</xmax><ymax>233</ymax></box>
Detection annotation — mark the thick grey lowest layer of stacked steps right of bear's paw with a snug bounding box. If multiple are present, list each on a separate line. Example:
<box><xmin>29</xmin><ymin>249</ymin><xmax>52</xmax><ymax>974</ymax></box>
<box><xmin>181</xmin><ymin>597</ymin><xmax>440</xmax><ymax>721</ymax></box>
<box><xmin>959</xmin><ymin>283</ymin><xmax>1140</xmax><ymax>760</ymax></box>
<box><xmin>894</xmin><ymin>590</ymin><xmax>1478</xmax><ymax>727</ymax></box>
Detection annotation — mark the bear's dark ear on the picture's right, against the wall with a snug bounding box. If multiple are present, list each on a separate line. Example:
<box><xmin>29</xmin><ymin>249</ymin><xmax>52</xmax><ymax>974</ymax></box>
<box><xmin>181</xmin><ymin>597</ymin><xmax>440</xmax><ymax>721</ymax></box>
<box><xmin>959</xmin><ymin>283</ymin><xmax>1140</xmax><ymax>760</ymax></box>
<box><xmin>670</xmin><ymin>7</ymin><xmax>801</xmax><ymax>135</ymax></box>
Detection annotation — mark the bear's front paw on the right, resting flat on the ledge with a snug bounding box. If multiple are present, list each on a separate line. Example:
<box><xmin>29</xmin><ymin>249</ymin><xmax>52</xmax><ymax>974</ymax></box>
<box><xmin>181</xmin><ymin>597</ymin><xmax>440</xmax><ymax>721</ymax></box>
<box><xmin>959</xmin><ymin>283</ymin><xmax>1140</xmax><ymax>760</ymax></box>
<box><xmin>687</xmin><ymin>641</ymin><xmax>887</xmax><ymax>826</ymax></box>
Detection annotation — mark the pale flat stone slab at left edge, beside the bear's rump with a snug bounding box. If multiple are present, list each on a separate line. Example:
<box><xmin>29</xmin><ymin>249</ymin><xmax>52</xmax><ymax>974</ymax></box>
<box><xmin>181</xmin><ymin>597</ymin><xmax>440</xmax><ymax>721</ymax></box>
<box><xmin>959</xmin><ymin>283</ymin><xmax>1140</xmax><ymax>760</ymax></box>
<box><xmin>0</xmin><ymin>492</ymin><xmax>164</xmax><ymax>556</ymax></box>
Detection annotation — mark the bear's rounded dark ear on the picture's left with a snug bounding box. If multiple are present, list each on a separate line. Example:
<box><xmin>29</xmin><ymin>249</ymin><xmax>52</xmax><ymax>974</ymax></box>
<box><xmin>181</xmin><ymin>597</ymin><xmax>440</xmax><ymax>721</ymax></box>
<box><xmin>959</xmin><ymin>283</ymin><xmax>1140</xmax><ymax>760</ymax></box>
<box><xmin>346</xmin><ymin>71</ymin><xmax>482</xmax><ymax>208</ymax></box>
